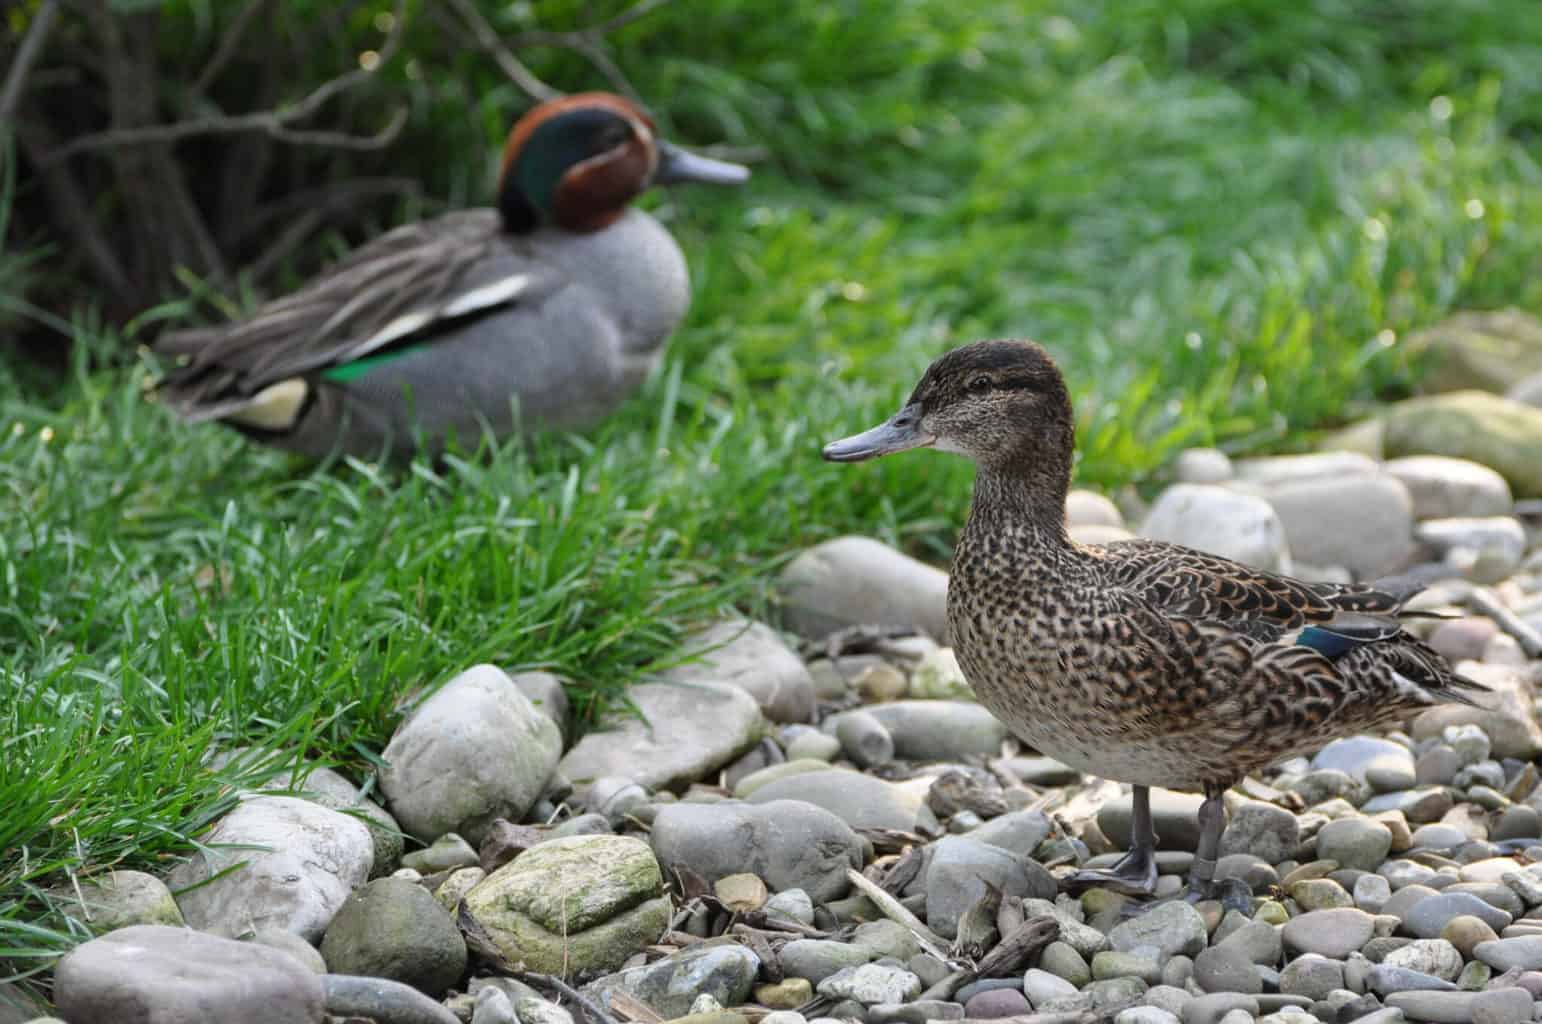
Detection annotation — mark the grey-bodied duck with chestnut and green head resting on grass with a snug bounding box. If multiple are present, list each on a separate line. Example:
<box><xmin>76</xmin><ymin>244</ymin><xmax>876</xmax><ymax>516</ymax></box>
<box><xmin>157</xmin><ymin>93</ymin><xmax>749</xmax><ymax>456</ymax></box>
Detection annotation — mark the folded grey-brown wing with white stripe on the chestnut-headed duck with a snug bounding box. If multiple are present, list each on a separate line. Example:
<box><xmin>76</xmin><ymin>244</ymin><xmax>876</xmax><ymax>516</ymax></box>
<box><xmin>156</xmin><ymin>210</ymin><xmax>564</xmax><ymax>421</ymax></box>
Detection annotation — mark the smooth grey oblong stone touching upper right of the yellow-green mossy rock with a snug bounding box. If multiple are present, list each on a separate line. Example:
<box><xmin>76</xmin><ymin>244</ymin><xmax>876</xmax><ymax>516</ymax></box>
<box><xmin>651</xmin><ymin>795</ymin><xmax>887</xmax><ymax>902</ymax></box>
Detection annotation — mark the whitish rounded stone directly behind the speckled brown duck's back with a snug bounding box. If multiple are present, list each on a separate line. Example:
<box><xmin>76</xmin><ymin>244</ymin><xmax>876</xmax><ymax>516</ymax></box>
<box><xmin>1141</xmin><ymin>484</ymin><xmax>1291</xmax><ymax>572</ymax></box>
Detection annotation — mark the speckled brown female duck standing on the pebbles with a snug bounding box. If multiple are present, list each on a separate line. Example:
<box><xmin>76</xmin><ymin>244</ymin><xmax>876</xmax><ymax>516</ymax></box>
<box><xmin>823</xmin><ymin>341</ymin><xmax>1483</xmax><ymax>899</ymax></box>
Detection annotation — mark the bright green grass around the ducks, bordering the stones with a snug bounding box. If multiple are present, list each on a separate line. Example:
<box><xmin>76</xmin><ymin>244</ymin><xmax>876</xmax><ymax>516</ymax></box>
<box><xmin>9</xmin><ymin>0</ymin><xmax>1542</xmax><ymax>970</ymax></box>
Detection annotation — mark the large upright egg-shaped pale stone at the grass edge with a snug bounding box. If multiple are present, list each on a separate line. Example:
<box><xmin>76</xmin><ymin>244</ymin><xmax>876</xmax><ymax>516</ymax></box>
<box><xmin>381</xmin><ymin>665</ymin><xmax>563</xmax><ymax>845</ymax></box>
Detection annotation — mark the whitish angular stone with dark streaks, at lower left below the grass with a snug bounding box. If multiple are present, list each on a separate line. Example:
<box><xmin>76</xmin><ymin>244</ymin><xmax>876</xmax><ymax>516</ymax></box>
<box><xmin>167</xmin><ymin>796</ymin><xmax>375</xmax><ymax>942</ymax></box>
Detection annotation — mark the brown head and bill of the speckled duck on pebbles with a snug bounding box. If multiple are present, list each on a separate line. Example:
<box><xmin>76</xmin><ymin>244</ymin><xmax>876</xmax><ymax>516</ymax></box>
<box><xmin>823</xmin><ymin>341</ymin><xmax>1075</xmax><ymax>478</ymax></box>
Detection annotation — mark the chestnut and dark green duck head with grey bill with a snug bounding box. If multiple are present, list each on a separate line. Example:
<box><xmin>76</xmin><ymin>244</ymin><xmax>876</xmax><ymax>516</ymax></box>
<box><xmin>498</xmin><ymin>93</ymin><xmax>749</xmax><ymax>233</ymax></box>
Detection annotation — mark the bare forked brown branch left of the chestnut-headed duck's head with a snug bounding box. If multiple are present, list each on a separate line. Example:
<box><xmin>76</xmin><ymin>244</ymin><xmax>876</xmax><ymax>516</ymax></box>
<box><xmin>45</xmin><ymin>0</ymin><xmax>407</xmax><ymax>165</ymax></box>
